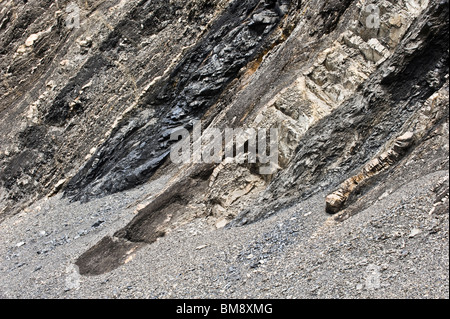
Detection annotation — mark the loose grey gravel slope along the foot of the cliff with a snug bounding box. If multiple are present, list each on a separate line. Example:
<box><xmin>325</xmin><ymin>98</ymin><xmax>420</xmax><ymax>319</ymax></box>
<box><xmin>0</xmin><ymin>171</ymin><xmax>449</xmax><ymax>298</ymax></box>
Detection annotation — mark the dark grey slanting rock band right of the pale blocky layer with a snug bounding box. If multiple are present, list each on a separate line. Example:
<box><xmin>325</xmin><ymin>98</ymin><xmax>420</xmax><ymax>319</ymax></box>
<box><xmin>230</xmin><ymin>2</ymin><xmax>448</xmax><ymax>225</ymax></box>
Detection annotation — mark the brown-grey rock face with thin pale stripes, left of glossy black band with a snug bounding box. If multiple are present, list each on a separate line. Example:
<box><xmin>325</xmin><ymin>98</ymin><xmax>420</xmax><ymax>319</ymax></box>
<box><xmin>0</xmin><ymin>0</ymin><xmax>236</xmax><ymax>218</ymax></box>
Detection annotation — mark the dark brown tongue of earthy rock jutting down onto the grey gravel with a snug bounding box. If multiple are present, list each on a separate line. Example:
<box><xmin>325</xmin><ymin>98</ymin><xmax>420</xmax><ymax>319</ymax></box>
<box><xmin>76</xmin><ymin>164</ymin><xmax>214</xmax><ymax>276</ymax></box>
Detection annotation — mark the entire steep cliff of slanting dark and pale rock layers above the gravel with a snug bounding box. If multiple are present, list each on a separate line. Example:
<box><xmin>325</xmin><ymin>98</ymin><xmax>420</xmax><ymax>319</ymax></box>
<box><xmin>0</xmin><ymin>0</ymin><xmax>449</xmax><ymax>300</ymax></box>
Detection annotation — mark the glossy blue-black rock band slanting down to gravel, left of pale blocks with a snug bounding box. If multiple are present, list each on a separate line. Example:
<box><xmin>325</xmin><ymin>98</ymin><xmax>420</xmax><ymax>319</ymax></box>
<box><xmin>65</xmin><ymin>0</ymin><xmax>292</xmax><ymax>200</ymax></box>
